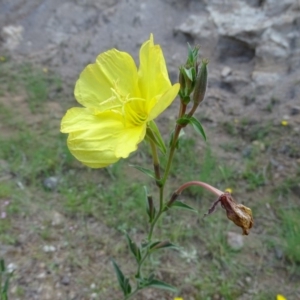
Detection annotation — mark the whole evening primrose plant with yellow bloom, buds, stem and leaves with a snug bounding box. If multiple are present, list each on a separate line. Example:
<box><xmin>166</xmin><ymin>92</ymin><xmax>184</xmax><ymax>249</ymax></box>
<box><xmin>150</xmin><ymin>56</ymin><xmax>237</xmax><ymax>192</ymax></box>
<box><xmin>61</xmin><ymin>34</ymin><xmax>253</xmax><ymax>299</ymax></box>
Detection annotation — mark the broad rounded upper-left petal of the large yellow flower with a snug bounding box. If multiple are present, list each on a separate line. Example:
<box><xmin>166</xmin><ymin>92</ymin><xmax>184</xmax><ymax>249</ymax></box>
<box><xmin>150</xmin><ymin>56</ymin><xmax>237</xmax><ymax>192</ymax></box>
<box><xmin>74</xmin><ymin>49</ymin><xmax>139</xmax><ymax>109</ymax></box>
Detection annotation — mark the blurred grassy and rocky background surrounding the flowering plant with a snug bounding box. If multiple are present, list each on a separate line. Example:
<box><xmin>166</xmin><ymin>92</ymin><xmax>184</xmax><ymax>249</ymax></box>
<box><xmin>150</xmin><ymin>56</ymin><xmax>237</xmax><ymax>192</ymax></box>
<box><xmin>0</xmin><ymin>0</ymin><xmax>300</xmax><ymax>300</ymax></box>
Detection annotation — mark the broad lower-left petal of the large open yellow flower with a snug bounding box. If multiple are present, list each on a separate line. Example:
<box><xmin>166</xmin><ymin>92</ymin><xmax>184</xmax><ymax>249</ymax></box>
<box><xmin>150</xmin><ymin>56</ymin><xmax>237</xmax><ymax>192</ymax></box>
<box><xmin>61</xmin><ymin>107</ymin><xmax>146</xmax><ymax>168</ymax></box>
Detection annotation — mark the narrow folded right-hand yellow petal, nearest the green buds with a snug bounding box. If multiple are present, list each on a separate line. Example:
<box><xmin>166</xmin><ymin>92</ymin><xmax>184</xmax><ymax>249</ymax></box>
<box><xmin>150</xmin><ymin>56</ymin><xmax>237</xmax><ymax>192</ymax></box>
<box><xmin>148</xmin><ymin>83</ymin><xmax>180</xmax><ymax>121</ymax></box>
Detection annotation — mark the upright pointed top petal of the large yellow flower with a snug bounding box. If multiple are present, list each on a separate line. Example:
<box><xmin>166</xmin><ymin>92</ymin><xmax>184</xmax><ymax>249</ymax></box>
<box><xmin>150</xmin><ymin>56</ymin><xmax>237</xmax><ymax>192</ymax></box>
<box><xmin>138</xmin><ymin>34</ymin><xmax>171</xmax><ymax>100</ymax></box>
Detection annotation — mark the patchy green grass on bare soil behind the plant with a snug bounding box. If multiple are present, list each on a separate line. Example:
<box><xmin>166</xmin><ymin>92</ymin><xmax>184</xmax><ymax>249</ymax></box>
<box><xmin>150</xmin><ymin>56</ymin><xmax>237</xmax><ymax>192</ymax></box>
<box><xmin>0</xmin><ymin>61</ymin><xmax>300</xmax><ymax>300</ymax></box>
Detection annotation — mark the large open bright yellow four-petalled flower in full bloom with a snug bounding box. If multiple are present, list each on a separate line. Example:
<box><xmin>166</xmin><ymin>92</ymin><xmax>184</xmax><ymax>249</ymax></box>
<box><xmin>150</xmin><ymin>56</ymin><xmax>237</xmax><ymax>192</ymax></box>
<box><xmin>61</xmin><ymin>34</ymin><xmax>179</xmax><ymax>168</ymax></box>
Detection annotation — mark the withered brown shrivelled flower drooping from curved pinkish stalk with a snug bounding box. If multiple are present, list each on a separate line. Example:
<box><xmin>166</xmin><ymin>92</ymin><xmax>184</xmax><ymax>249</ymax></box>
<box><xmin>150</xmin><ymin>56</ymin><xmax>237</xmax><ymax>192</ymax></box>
<box><xmin>206</xmin><ymin>192</ymin><xmax>253</xmax><ymax>235</ymax></box>
